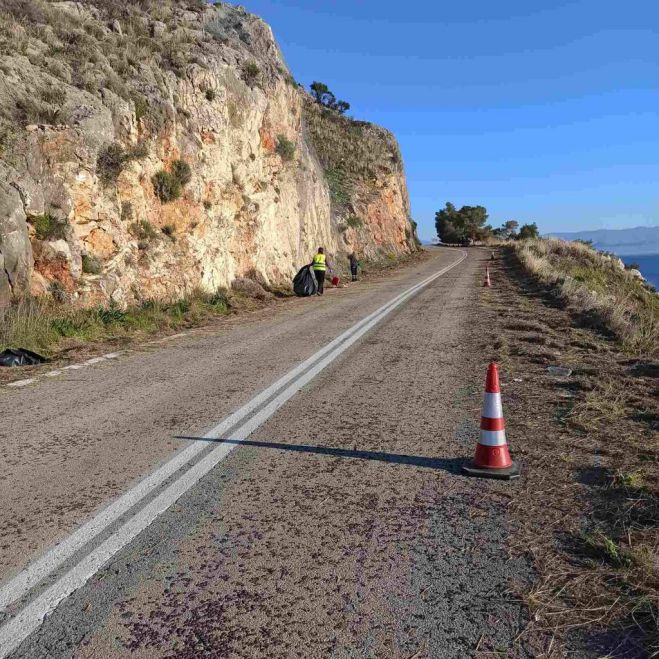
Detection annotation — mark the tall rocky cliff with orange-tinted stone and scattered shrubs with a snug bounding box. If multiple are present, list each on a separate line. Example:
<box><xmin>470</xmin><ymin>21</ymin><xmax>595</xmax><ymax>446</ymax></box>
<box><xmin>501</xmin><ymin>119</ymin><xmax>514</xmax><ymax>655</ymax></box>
<box><xmin>0</xmin><ymin>0</ymin><xmax>416</xmax><ymax>306</ymax></box>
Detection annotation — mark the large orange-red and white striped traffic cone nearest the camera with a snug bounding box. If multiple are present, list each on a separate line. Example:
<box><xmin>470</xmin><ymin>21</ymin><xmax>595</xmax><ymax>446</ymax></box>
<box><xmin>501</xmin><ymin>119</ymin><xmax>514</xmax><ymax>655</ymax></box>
<box><xmin>462</xmin><ymin>364</ymin><xmax>521</xmax><ymax>480</ymax></box>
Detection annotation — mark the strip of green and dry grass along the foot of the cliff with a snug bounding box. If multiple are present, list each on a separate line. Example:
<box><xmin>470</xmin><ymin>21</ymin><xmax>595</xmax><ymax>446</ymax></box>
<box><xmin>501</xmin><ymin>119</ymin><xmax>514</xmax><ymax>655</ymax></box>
<box><xmin>0</xmin><ymin>254</ymin><xmax>425</xmax><ymax>360</ymax></box>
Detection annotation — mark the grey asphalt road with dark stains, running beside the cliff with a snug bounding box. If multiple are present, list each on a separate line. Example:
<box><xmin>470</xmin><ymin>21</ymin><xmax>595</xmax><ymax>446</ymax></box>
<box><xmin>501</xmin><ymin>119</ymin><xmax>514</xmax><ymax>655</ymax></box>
<box><xmin>0</xmin><ymin>250</ymin><xmax>530</xmax><ymax>658</ymax></box>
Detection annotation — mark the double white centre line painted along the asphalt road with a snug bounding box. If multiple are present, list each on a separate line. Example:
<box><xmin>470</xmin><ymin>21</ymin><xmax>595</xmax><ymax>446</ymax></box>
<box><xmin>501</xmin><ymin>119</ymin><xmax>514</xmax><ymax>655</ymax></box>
<box><xmin>0</xmin><ymin>252</ymin><xmax>467</xmax><ymax>657</ymax></box>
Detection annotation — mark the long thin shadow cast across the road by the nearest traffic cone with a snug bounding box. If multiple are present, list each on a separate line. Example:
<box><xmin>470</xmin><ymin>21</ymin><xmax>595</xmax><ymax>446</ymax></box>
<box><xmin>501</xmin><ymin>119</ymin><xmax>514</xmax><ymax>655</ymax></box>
<box><xmin>176</xmin><ymin>435</ymin><xmax>465</xmax><ymax>473</ymax></box>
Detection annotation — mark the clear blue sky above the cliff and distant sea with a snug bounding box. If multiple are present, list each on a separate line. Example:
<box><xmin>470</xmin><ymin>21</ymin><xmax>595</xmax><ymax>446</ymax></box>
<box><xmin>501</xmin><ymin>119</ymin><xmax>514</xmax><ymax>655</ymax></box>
<box><xmin>232</xmin><ymin>0</ymin><xmax>659</xmax><ymax>238</ymax></box>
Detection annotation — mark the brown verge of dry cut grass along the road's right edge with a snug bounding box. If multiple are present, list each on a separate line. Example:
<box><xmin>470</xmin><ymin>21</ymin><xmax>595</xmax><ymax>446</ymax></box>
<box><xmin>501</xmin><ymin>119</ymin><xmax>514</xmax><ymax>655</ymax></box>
<box><xmin>481</xmin><ymin>246</ymin><xmax>659</xmax><ymax>658</ymax></box>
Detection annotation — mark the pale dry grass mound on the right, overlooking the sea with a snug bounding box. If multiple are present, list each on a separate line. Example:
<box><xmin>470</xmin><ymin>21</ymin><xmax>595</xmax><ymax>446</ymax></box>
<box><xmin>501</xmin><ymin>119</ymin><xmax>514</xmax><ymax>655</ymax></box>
<box><xmin>514</xmin><ymin>239</ymin><xmax>659</xmax><ymax>357</ymax></box>
